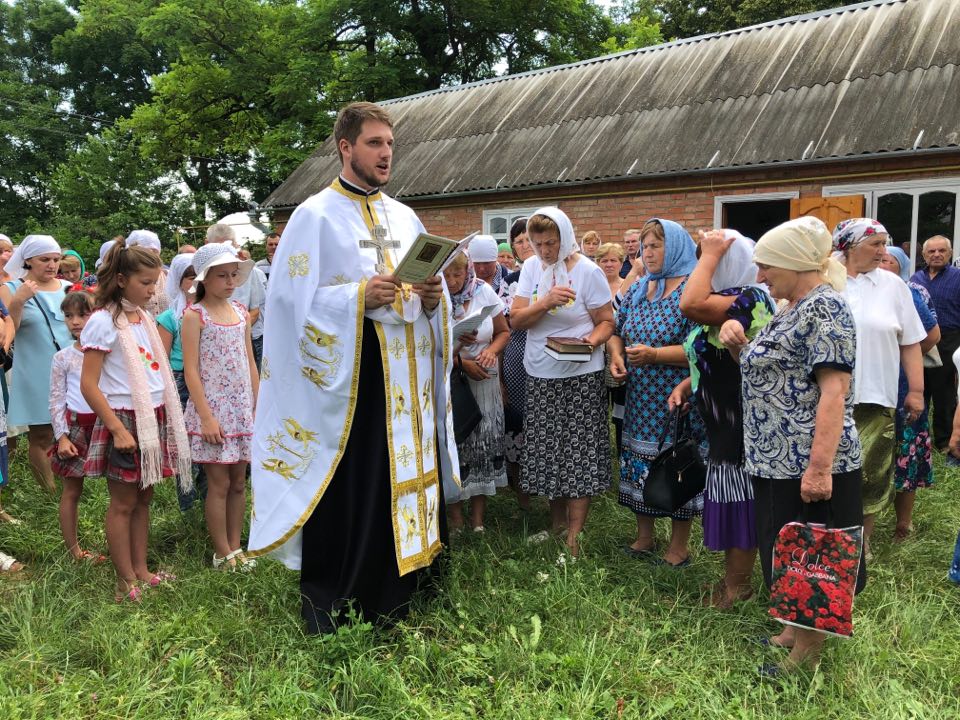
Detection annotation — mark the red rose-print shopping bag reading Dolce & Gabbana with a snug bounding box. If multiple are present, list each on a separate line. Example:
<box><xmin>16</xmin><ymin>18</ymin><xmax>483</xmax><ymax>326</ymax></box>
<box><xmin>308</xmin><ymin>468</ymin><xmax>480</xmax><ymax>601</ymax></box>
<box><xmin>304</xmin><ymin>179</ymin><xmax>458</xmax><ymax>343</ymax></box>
<box><xmin>770</xmin><ymin>510</ymin><xmax>863</xmax><ymax>637</ymax></box>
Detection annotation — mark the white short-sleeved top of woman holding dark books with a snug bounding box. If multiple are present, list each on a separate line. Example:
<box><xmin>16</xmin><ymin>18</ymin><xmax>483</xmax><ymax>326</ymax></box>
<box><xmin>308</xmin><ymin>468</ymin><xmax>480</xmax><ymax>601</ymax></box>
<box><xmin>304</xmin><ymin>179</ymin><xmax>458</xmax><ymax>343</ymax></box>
<box><xmin>517</xmin><ymin>255</ymin><xmax>610</xmax><ymax>378</ymax></box>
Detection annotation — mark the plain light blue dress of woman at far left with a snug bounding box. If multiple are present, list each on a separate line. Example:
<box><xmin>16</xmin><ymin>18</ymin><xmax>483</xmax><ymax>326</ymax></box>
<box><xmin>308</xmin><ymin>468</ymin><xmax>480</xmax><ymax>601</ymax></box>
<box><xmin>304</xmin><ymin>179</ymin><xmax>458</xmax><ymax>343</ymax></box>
<box><xmin>6</xmin><ymin>280</ymin><xmax>73</xmax><ymax>425</ymax></box>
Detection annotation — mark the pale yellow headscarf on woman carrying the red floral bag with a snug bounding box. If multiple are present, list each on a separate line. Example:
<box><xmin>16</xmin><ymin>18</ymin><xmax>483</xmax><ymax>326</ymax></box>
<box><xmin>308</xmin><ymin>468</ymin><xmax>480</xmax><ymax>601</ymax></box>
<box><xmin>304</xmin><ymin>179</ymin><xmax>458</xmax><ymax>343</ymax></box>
<box><xmin>753</xmin><ymin>216</ymin><xmax>847</xmax><ymax>292</ymax></box>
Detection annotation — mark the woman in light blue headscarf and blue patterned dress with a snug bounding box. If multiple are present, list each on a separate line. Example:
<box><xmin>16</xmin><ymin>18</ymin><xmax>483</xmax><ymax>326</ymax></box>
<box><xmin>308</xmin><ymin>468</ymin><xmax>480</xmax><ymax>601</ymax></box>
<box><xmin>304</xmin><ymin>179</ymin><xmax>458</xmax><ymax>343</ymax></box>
<box><xmin>607</xmin><ymin>218</ymin><xmax>703</xmax><ymax>568</ymax></box>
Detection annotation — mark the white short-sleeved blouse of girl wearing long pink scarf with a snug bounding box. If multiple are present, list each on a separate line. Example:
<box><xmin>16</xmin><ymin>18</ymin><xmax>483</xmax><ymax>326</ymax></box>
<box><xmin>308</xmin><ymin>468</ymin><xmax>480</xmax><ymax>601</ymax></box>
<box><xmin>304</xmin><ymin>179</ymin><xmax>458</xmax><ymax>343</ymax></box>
<box><xmin>80</xmin><ymin>310</ymin><xmax>163</xmax><ymax>410</ymax></box>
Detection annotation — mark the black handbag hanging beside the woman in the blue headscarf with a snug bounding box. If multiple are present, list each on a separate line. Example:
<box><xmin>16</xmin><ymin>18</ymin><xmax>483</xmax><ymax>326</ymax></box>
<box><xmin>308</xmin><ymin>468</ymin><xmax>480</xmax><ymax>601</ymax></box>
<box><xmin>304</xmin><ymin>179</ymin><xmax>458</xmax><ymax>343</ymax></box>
<box><xmin>643</xmin><ymin>409</ymin><xmax>707</xmax><ymax>513</ymax></box>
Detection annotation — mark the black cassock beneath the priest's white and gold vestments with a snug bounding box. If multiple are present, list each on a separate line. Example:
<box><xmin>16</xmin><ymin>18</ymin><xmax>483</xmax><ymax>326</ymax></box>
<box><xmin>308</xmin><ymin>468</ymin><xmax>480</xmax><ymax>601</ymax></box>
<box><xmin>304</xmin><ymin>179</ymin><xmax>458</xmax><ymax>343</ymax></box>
<box><xmin>300</xmin><ymin>318</ymin><xmax>447</xmax><ymax>633</ymax></box>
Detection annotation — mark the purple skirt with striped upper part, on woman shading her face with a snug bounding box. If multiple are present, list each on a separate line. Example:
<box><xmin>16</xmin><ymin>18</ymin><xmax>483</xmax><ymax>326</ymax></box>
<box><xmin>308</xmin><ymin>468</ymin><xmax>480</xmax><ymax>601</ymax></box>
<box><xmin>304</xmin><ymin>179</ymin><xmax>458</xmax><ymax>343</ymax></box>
<box><xmin>703</xmin><ymin>461</ymin><xmax>757</xmax><ymax>551</ymax></box>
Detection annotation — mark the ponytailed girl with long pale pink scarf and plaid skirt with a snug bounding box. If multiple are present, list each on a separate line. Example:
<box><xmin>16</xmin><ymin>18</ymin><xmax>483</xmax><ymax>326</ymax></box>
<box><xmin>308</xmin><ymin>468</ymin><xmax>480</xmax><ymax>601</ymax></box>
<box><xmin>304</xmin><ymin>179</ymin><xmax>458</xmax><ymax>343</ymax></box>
<box><xmin>80</xmin><ymin>244</ymin><xmax>191</xmax><ymax>602</ymax></box>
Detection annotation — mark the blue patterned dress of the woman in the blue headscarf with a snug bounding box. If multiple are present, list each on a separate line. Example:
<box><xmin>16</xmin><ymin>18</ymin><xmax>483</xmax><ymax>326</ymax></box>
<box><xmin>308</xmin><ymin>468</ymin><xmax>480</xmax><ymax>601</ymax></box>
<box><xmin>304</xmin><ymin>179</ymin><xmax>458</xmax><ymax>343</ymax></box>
<box><xmin>617</xmin><ymin>280</ymin><xmax>705</xmax><ymax>520</ymax></box>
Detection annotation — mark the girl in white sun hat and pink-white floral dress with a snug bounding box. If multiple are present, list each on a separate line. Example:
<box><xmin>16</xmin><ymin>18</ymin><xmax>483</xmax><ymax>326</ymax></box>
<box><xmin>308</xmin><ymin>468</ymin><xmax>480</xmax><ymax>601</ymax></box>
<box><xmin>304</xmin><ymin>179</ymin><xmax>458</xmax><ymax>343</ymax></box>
<box><xmin>181</xmin><ymin>243</ymin><xmax>259</xmax><ymax>570</ymax></box>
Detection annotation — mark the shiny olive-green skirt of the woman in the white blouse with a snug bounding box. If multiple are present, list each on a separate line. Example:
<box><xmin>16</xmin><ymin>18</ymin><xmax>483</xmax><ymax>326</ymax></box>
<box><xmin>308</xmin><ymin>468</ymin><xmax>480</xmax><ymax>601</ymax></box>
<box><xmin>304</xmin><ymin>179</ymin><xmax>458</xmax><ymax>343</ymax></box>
<box><xmin>853</xmin><ymin>403</ymin><xmax>895</xmax><ymax>515</ymax></box>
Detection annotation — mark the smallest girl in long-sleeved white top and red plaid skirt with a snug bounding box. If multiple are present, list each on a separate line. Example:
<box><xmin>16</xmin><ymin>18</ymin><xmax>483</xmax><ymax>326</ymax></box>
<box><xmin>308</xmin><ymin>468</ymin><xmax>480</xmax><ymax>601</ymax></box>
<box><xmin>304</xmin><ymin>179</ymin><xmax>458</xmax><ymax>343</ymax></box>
<box><xmin>50</xmin><ymin>290</ymin><xmax>106</xmax><ymax>564</ymax></box>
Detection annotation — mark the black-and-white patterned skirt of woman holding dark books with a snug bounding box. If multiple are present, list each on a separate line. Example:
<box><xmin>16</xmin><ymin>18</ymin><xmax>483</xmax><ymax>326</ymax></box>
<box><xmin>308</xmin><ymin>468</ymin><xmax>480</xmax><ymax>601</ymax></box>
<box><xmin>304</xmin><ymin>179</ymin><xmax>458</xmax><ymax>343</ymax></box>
<box><xmin>520</xmin><ymin>370</ymin><xmax>610</xmax><ymax>500</ymax></box>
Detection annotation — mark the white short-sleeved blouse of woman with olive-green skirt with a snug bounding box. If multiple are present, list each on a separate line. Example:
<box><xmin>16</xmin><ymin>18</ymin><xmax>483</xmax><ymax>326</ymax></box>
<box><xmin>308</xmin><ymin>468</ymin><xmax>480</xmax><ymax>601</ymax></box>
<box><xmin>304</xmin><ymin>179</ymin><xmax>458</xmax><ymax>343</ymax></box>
<box><xmin>843</xmin><ymin>268</ymin><xmax>927</xmax><ymax>408</ymax></box>
